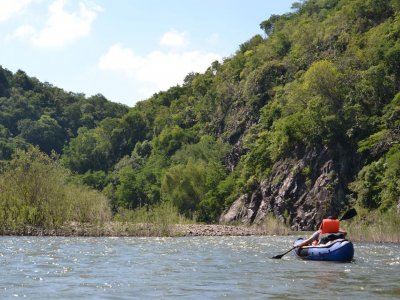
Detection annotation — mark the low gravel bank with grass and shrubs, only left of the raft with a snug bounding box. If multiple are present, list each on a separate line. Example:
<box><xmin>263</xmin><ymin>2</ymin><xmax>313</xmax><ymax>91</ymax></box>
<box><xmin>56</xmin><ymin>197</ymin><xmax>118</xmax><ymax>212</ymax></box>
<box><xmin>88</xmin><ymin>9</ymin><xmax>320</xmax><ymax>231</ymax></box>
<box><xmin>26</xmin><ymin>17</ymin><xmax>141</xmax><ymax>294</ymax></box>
<box><xmin>0</xmin><ymin>202</ymin><xmax>290</xmax><ymax>237</ymax></box>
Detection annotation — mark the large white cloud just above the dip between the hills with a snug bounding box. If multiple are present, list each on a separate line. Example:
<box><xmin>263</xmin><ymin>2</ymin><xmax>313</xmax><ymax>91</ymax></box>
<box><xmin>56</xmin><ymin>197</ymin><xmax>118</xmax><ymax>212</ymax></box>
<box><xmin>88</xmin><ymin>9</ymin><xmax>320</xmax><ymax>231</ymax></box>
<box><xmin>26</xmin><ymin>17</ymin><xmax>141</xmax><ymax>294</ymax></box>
<box><xmin>99</xmin><ymin>44</ymin><xmax>221</xmax><ymax>97</ymax></box>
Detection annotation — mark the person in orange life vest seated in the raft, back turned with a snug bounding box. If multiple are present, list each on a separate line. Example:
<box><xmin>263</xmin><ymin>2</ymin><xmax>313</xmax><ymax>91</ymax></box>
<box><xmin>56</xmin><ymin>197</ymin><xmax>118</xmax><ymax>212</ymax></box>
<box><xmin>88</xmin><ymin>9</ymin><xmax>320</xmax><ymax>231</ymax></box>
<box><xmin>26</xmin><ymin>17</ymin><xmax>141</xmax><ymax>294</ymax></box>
<box><xmin>297</xmin><ymin>216</ymin><xmax>347</xmax><ymax>248</ymax></box>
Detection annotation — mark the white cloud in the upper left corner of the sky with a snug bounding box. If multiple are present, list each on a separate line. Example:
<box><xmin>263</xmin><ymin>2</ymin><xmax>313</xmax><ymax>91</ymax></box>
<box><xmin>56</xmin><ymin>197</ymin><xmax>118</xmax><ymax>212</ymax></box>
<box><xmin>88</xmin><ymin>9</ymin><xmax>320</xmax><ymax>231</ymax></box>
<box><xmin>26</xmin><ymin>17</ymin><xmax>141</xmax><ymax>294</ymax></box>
<box><xmin>14</xmin><ymin>0</ymin><xmax>101</xmax><ymax>48</ymax></box>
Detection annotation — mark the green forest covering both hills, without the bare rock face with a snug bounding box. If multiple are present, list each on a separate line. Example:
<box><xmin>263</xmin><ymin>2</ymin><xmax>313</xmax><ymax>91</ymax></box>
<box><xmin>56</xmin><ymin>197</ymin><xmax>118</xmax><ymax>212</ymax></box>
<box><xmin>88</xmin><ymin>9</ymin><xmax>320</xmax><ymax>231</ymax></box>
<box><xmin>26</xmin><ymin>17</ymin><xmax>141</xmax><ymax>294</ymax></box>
<box><xmin>0</xmin><ymin>0</ymin><xmax>400</xmax><ymax>232</ymax></box>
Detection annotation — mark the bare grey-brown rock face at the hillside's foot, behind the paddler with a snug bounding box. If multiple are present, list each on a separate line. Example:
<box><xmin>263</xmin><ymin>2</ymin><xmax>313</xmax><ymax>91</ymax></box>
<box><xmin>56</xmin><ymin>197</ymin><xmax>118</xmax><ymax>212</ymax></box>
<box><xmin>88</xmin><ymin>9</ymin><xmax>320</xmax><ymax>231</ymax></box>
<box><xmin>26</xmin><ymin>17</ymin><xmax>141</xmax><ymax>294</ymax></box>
<box><xmin>220</xmin><ymin>147</ymin><xmax>354</xmax><ymax>230</ymax></box>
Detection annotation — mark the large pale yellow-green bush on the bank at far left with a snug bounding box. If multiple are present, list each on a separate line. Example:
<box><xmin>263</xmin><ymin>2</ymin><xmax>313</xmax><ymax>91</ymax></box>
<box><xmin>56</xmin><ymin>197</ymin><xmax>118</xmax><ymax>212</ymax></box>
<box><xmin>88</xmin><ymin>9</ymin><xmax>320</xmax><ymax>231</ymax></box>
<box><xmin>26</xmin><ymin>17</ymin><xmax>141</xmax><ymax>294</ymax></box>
<box><xmin>0</xmin><ymin>147</ymin><xmax>111</xmax><ymax>230</ymax></box>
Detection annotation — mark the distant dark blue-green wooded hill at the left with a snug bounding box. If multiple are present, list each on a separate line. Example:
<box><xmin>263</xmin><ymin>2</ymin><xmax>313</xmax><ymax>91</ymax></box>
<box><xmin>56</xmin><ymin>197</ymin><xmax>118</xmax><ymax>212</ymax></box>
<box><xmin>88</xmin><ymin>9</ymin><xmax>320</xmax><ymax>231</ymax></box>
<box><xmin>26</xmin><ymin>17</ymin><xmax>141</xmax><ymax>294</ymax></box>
<box><xmin>0</xmin><ymin>66</ymin><xmax>128</xmax><ymax>159</ymax></box>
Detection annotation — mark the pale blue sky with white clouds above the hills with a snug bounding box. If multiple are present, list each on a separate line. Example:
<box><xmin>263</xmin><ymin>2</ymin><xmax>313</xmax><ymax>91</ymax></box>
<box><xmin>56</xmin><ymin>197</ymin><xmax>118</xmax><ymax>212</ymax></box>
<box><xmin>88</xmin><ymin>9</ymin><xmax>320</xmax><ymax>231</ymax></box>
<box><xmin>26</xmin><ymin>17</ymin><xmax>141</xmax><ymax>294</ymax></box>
<box><xmin>0</xmin><ymin>0</ymin><xmax>295</xmax><ymax>107</ymax></box>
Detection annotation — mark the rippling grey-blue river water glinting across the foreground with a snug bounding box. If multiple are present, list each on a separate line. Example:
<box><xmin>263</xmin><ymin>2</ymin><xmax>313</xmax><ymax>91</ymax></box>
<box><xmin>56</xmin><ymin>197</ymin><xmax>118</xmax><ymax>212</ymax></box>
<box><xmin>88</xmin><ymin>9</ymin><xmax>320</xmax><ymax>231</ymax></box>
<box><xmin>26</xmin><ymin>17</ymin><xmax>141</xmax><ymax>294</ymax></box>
<box><xmin>0</xmin><ymin>236</ymin><xmax>400</xmax><ymax>299</ymax></box>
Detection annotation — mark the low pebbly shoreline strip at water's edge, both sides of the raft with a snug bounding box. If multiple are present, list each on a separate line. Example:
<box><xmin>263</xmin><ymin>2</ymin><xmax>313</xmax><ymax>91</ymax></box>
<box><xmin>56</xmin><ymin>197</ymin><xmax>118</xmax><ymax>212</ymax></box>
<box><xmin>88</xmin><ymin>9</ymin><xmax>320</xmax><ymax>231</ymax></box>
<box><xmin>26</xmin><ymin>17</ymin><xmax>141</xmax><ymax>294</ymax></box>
<box><xmin>0</xmin><ymin>222</ymin><xmax>400</xmax><ymax>243</ymax></box>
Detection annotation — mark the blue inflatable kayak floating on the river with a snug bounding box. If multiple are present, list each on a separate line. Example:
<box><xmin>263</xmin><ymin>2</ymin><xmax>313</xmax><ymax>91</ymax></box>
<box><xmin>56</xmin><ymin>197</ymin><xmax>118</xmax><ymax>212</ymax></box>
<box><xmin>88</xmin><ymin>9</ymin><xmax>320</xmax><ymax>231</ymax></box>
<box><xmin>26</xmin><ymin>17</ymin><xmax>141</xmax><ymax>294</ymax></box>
<box><xmin>294</xmin><ymin>238</ymin><xmax>354</xmax><ymax>262</ymax></box>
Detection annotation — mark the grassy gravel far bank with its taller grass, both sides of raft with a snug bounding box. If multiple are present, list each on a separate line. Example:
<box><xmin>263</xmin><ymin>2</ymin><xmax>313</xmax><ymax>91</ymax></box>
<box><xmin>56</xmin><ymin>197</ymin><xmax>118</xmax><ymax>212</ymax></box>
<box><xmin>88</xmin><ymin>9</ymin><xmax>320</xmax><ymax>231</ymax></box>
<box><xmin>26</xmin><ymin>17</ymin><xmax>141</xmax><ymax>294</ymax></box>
<box><xmin>0</xmin><ymin>211</ymin><xmax>400</xmax><ymax>243</ymax></box>
